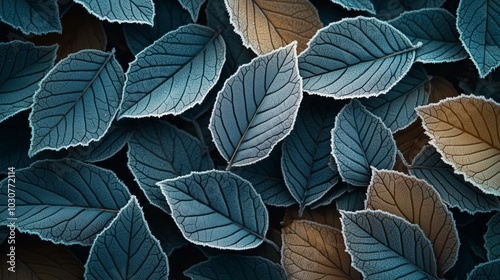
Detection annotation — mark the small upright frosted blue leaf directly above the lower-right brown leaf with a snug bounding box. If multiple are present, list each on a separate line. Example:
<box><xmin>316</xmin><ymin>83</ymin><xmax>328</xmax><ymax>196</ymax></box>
<box><xmin>332</xmin><ymin>100</ymin><xmax>396</xmax><ymax>186</ymax></box>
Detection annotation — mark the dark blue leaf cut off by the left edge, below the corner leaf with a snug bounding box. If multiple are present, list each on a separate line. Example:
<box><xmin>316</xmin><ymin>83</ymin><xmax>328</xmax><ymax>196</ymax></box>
<box><xmin>0</xmin><ymin>41</ymin><xmax>58</xmax><ymax>122</ymax></box>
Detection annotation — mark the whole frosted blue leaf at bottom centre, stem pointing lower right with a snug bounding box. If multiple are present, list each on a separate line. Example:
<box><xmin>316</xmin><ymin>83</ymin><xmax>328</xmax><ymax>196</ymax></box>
<box><xmin>158</xmin><ymin>170</ymin><xmax>268</xmax><ymax>250</ymax></box>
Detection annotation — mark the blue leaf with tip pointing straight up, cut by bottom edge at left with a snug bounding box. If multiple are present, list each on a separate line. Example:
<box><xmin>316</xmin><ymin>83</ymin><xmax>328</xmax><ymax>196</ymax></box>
<box><xmin>85</xmin><ymin>196</ymin><xmax>168</xmax><ymax>279</ymax></box>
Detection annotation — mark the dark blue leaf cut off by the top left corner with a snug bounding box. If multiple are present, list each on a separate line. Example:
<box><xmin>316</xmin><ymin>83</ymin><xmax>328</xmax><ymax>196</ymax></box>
<box><xmin>0</xmin><ymin>0</ymin><xmax>62</xmax><ymax>35</ymax></box>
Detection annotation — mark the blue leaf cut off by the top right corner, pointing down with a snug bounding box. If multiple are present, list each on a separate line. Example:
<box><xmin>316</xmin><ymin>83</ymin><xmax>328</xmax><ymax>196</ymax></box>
<box><xmin>457</xmin><ymin>0</ymin><xmax>500</xmax><ymax>78</ymax></box>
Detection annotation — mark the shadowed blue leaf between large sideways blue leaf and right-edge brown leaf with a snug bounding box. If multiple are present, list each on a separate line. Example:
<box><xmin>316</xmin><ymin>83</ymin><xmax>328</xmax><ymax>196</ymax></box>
<box><xmin>360</xmin><ymin>65</ymin><xmax>429</xmax><ymax>133</ymax></box>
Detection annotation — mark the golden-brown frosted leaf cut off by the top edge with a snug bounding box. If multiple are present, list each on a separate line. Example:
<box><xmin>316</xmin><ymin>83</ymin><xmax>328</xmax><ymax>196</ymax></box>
<box><xmin>225</xmin><ymin>0</ymin><xmax>323</xmax><ymax>55</ymax></box>
